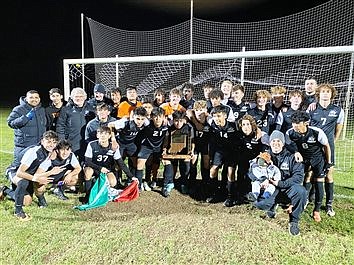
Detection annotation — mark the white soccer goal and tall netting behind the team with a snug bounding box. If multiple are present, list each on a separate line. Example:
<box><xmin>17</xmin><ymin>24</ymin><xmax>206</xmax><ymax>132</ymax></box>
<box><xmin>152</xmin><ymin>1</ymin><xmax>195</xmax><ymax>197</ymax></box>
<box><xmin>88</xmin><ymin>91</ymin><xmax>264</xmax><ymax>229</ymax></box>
<box><xmin>64</xmin><ymin>0</ymin><xmax>354</xmax><ymax>169</ymax></box>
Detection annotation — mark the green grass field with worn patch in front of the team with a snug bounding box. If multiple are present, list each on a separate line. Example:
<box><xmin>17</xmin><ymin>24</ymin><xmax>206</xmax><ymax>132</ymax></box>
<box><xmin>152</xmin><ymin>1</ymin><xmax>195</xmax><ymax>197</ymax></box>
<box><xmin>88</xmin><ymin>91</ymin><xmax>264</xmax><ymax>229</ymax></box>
<box><xmin>0</xmin><ymin>106</ymin><xmax>354</xmax><ymax>264</ymax></box>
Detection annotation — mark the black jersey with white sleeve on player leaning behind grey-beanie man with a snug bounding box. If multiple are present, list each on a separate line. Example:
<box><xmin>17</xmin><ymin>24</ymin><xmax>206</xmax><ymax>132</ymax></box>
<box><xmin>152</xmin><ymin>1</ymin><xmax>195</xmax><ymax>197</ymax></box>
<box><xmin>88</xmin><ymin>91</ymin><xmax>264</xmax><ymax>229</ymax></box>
<box><xmin>286</xmin><ymin>126</ymin><xmax>328</xmax><ymax>160</ymax></box>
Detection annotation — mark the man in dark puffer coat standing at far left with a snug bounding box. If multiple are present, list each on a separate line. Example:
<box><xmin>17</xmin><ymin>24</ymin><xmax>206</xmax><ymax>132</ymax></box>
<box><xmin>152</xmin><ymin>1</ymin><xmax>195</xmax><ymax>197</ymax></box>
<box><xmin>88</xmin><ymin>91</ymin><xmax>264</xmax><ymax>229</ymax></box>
<box><xmin>7</xmin><ymin>90</ymin><xmax>46</xmax><ymax>163</ymax></box>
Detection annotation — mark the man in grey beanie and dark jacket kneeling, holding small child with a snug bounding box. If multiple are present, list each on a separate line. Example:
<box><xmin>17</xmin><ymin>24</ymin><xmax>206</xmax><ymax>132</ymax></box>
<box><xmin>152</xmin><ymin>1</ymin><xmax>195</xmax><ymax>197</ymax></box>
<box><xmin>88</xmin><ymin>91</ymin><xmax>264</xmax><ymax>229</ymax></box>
<box><xmin>254</xmin><ymin>130</ymin><xmax>306</xmax><ymax>236</ymax></box>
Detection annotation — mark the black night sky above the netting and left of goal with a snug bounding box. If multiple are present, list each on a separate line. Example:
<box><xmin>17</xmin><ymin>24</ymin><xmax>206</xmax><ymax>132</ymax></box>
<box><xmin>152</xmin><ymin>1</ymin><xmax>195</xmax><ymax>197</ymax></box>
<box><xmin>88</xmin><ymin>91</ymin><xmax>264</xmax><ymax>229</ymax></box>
<box><xmin>0</xmin><ymin>0</ymin><xmax>326</xmax><ymax>107</ymax></box>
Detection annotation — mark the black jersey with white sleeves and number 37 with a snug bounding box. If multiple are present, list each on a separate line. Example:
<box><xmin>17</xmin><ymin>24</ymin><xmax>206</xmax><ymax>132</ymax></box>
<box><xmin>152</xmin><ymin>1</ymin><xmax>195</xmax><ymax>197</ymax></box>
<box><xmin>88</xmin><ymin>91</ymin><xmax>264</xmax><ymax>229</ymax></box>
<box><xmin>85</xmin><ymin>140</ymin><xmax>121</xmax><ymax>169</ymax></box>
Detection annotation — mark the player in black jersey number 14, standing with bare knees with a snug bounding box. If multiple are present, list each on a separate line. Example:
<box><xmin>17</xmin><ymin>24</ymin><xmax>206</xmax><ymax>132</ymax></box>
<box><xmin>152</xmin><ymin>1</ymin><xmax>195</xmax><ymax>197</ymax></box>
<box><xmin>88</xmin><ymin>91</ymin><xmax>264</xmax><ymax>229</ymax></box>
<box><xmin>207</xmin><ymin>105</ymin><xmax>236</xmax><ymax>207</ymax></box>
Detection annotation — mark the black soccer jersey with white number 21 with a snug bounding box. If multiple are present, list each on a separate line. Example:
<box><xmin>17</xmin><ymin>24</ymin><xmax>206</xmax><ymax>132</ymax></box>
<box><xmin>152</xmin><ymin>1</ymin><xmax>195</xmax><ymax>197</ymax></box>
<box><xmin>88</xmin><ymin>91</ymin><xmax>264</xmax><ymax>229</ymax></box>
<box><xmin>140</xmin><ymin>122</ymin><xmax>168</xmax><ymax>148</ymax></box>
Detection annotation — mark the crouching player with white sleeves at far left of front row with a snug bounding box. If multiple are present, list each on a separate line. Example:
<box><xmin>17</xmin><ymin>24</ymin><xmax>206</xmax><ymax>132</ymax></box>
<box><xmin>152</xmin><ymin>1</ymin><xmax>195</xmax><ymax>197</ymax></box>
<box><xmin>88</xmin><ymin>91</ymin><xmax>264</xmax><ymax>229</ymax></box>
<box><xmin>3</xmin><ymin>131</ymin><xmax>64</xmax><ymax>221</ymax></box>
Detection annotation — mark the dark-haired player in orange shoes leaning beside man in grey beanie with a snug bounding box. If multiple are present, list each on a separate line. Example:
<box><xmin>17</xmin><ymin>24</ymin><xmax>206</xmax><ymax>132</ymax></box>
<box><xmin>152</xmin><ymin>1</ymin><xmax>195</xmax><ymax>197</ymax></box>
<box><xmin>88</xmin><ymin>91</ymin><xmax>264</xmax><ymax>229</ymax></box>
<box><xmin>286</xmin><ymin>110</ymin><xmax>333</xmax><ymax>222</ymax></box>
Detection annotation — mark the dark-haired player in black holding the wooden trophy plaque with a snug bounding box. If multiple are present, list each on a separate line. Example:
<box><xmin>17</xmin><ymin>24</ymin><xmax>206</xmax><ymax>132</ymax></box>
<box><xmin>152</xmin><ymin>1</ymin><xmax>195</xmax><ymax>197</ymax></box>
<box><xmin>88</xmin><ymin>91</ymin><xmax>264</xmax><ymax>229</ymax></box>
<box><xmin>162</xmin><ymin>111</ymin><xmax>195</xmax><ymax>197</ymax></box>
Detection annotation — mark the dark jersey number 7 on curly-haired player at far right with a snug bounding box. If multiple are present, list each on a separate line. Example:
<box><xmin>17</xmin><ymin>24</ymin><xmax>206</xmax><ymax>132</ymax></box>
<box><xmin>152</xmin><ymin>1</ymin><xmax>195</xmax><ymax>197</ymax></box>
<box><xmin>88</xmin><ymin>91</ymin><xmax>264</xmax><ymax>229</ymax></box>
<box><xmin>310</xmin><ymin>103</ymin><xmax>344</xmax><ymax>141</ymax></box>
